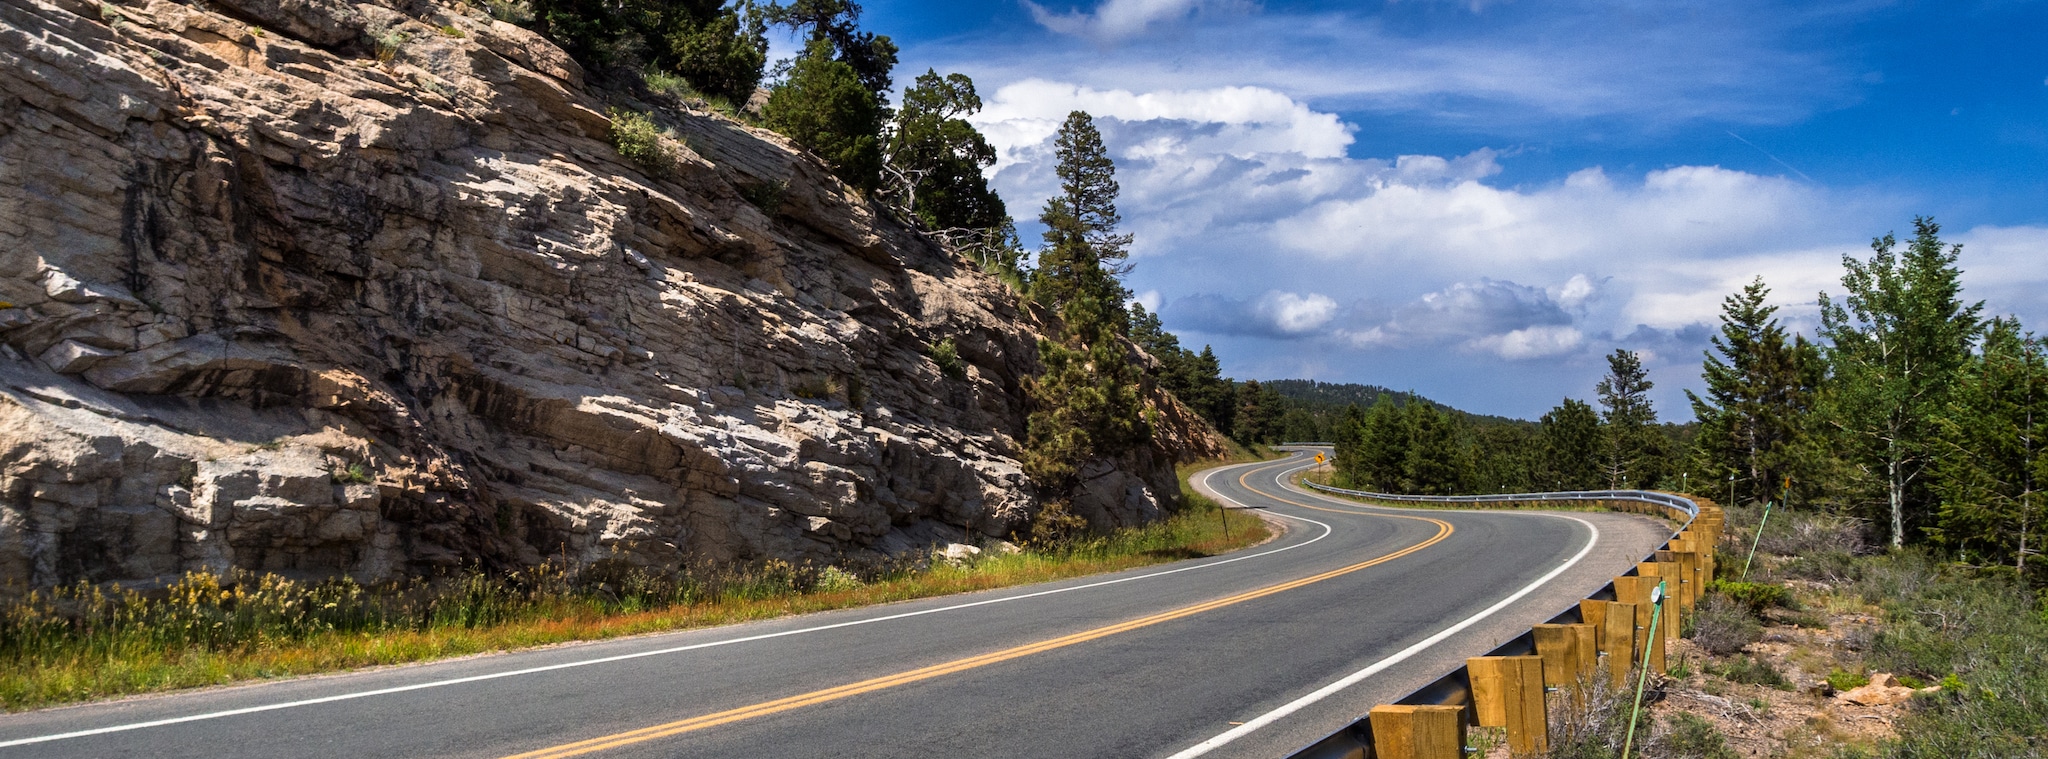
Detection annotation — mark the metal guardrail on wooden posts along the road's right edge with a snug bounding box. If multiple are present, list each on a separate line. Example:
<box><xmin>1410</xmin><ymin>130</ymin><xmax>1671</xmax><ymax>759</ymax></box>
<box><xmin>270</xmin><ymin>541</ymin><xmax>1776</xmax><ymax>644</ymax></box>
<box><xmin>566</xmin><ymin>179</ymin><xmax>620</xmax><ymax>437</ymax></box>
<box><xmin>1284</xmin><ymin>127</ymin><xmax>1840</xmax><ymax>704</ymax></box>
<box><xmin>1286</xmin><ymin>483</ymin><xmax>1700</xmax><ymax>759</ymax></box>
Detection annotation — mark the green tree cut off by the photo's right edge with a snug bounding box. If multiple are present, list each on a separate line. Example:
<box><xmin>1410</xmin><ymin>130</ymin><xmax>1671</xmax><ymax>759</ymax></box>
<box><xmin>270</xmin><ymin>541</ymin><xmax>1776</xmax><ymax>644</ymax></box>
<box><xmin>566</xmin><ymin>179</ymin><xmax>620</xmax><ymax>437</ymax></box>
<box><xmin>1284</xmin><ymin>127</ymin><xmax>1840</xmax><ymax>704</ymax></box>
<box><xmin>1929</xmin><ymin>319</ymin><xmax>2048</xmax><ymax>575</ymax></box>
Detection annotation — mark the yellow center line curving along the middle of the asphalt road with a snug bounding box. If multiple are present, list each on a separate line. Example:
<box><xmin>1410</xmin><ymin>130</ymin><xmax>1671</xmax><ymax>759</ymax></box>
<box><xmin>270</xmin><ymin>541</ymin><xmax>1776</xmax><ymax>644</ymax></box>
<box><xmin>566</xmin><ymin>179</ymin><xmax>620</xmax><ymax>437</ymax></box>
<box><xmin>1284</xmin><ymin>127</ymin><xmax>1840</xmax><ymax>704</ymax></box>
<box><xmin>506</xmin><ymin>458</ymin><xmax>1454</xmax><ymax>759</ymax></box>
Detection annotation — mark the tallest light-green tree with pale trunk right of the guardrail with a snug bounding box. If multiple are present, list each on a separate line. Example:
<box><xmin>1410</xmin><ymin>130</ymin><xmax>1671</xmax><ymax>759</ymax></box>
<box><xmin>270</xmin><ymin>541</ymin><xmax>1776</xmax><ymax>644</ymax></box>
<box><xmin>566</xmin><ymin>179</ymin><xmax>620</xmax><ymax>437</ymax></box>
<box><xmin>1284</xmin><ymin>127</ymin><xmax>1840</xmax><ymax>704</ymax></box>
<box><xmin>1821</xmin><ymin>217</ymin><xmax>1982</xmax><ymax>548</ymax></box>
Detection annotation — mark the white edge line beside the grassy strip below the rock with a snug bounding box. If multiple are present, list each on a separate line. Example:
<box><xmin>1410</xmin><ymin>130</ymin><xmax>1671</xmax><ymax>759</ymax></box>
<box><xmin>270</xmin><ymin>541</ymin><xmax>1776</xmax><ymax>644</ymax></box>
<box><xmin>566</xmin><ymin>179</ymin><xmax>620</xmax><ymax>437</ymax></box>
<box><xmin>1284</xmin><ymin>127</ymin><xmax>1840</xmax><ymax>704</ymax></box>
<box><xmin>0</xmin><ymin>462</ymin><xmax>1333</xmax><ymax>749</ymax></box>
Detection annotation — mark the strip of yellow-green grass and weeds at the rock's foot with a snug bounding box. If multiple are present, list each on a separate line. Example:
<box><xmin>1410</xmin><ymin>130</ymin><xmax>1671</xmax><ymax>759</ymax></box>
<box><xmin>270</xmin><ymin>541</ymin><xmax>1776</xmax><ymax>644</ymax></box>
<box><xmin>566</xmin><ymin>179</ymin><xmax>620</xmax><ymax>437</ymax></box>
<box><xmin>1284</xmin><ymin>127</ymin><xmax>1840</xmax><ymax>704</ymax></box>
<box><xmin>0</xmin><ymin>456</ymin><xmax>1270</xmax><ymax>712</ymax></box>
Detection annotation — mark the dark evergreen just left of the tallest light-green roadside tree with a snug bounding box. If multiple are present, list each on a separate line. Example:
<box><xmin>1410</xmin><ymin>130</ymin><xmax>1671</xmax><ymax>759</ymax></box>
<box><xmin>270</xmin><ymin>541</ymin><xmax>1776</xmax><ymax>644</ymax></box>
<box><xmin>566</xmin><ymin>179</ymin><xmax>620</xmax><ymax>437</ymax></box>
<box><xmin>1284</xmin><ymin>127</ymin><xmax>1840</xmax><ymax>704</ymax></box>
<box><xmin>1686</xmin><ymin>278</ymin><xmax>1817</xmax><ymax>501</ymax></box>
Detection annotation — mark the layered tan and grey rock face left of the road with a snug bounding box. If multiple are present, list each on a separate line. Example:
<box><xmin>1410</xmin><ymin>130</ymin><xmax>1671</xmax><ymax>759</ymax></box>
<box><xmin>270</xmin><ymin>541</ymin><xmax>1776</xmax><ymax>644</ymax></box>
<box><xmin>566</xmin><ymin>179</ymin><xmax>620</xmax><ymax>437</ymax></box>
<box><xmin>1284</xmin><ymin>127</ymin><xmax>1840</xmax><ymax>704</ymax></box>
<box><xmin>0</xmin><ymin>0</ymin><xmax>1219</xmax><ymax>587</ymax></box>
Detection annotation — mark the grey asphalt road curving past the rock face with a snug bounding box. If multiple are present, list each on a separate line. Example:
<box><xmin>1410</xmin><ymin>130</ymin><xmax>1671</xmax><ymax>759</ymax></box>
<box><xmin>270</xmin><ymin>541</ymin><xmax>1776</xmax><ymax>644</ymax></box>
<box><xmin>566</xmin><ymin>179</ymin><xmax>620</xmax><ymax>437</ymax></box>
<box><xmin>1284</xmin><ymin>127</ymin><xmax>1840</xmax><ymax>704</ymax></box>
<box><xmin>0</xmin><ymin>454</ymin><xmax>1669</xmax><ymax>757</ymax></box>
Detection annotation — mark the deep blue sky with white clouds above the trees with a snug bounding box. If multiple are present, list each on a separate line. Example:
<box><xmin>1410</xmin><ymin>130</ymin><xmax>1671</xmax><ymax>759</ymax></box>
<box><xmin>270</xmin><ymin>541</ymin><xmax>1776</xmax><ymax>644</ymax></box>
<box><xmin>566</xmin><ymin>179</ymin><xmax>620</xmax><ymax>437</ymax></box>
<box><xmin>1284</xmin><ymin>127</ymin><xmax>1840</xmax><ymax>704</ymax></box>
<box><xmin>835</xmin><ymin>0</ymin><xmax>2048</xmax><ymax>419</ymax></box>
